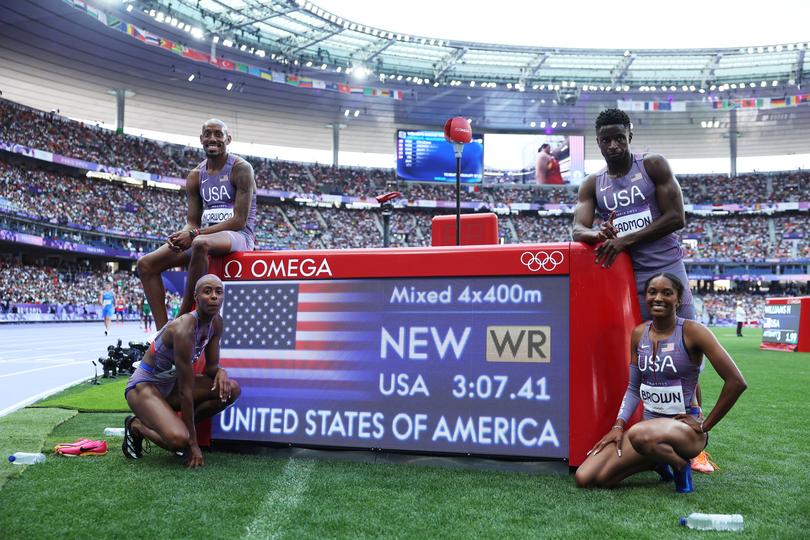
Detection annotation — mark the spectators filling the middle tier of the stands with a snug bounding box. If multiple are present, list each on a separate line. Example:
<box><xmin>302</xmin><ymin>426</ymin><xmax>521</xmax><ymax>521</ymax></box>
<box><xmin>0</xmin><ymin>153</ymin><xmax>810</xmax><ymax>261</ymax></box>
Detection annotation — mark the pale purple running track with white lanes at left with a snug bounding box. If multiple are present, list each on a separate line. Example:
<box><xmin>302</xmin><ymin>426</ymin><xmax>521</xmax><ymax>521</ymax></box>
<box><xmin>0</xmin><ymin>321</ymin><xmax>154</xmax><ymax>416</ymax></box>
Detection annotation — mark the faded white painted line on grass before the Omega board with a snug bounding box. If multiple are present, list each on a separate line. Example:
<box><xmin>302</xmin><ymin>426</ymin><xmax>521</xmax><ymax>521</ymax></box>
<box><xmin>243</xmin><ymin>458</ymin><xmax>316</xmax><ymax>540</ymax></box>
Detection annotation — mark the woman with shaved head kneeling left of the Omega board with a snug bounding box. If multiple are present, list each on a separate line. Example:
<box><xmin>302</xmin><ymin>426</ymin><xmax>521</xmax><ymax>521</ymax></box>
<box><xmin>122</xmin><ymin>274</ymin><xmax>240</xmax><ymax>468</ymax></box>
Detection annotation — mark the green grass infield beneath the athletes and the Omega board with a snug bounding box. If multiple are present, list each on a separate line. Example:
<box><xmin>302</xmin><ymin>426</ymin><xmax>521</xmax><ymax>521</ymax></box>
<box><xmin>0</xmin><ymin>329</ymin><xmax>810</xmax><ymax>540</ymax></box>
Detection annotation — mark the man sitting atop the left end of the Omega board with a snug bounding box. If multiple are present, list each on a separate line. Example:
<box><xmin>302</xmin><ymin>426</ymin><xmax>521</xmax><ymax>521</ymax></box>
<box><xmin>138</xmin><ymin>119</ymin><xmax>256</xmax><ymax>329</ymax></box>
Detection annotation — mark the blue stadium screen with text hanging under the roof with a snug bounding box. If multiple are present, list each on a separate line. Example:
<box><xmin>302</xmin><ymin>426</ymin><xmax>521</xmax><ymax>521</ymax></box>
<box><xmin>397</xmin><ymin>129</ymin><xmax>484</xmax><ymax>184</ymax></box>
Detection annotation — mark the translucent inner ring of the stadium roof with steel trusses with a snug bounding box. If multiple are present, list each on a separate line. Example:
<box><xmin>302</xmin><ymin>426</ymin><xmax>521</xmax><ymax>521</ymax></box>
<box><xmin>148</xmin><ymin>0</ymin><xmax>810</xmax><ymax>94</ymax></box>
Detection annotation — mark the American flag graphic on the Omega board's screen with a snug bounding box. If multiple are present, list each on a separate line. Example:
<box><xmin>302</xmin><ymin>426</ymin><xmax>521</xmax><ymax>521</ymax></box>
<box><xmin>220</xmin><ymin>280</ymin><xmax>379</xmax><ymax>400</ymax></box>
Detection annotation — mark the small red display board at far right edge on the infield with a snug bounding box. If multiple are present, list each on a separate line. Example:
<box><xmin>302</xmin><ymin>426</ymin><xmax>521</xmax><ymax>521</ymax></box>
<box><xmin>760</xmin><ymin>296</ymin><xmax>810</xmax><ymax>352</ymax></box>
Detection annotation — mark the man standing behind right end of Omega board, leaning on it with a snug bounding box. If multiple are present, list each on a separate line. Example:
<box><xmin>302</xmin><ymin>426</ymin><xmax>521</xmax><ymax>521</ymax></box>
<box><xmin>572</xmin><ymin>109</ymin><xmax>695</xmax><ymax>321</ymax></box>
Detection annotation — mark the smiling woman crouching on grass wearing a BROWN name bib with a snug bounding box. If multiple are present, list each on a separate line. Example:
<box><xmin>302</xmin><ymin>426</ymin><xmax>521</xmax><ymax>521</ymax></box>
<box><xmin>576</xmin><ymin>273</ymin><xmax>746</xmax><ymax>493</ymax></box>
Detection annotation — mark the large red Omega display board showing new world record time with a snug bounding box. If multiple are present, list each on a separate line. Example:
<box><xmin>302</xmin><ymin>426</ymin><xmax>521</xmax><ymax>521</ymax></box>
<box><xmin>211</xmin><ymin>243</ymin><xmax>640</xmax><ymax>466</ymax></box>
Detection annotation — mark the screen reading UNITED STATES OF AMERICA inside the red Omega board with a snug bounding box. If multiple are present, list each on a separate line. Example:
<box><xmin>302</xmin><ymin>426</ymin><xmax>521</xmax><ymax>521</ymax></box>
<box><xmin>215</xmin><ymin>276</ymin><xmax>568</xmax><ymax>458</ymax></box>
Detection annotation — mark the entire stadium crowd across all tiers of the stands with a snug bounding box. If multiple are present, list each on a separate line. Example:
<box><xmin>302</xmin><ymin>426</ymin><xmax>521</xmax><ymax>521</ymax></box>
<box><xmin>0</xmin><ymin>99</ymin><xmax>810</xmax><ymax>318</ymax></box>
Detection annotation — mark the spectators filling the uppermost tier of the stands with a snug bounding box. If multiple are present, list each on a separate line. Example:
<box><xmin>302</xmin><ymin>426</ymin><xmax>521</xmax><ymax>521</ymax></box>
<box><xmin>0</xmin><ymin>99</ymin><xmax>810</xmax><ymax>204</ymax></box>
